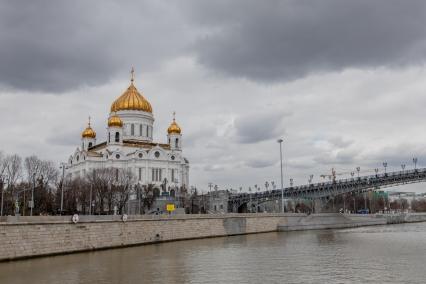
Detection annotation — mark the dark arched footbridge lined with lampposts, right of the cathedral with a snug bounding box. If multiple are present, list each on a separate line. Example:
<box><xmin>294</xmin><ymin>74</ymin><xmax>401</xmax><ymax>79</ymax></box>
<box><xmin>228</xmin><ymin>168</ymin><xmax>426</xmax><ymax>212</ymax></box>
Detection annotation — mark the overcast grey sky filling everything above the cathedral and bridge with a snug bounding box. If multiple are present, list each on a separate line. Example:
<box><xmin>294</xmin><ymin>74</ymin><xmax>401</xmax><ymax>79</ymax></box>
<box><xmin>0</xmin><ymin>0</ymin><xmax>426</xmax><ymax>192</ymax></box>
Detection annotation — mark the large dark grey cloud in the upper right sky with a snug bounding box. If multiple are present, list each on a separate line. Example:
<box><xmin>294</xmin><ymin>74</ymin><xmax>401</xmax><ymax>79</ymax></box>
<box><xmin>188</xmin><ymin>0</ymin><xmax>426</xmax><ymax>81</ymax></box>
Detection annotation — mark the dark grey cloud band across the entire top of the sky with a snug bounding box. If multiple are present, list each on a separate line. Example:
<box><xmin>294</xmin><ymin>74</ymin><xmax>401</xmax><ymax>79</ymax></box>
<box><xmin>0</xmin><ymin>0</ymin><xmax>426</xmax><ymax>93</ymax></box>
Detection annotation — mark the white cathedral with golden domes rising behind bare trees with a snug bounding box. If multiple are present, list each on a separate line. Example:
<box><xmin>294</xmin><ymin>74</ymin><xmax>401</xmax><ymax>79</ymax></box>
<box><xmin>66</xmin><ymin>70</ymin><xmax>189</xmax><ymax>196</ymax></box>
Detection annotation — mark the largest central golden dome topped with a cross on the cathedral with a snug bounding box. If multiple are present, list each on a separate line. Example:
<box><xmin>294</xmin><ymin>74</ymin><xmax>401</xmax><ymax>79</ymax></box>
<box><xmin>111</xmin><ymin>68</ymin><xmax>152</xmax><ymax>113</ymax></box>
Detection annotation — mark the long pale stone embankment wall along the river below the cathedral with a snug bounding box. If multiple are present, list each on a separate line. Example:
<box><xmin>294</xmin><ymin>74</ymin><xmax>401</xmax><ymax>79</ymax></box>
<box><xmin>0</xmin><ymin>214</ymin><xmax>306</xmax><ymax>260</ymax></box>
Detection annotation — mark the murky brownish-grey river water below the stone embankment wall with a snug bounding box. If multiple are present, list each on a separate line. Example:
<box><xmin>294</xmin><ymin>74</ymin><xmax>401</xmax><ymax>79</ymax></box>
<box><xmin>0</xmin><ymin>223</ymin><xmax>426</xmax><ymax>284</ymax></box>
